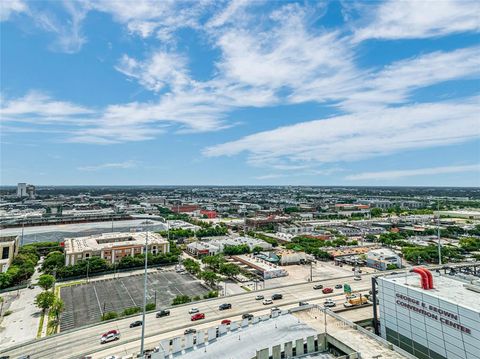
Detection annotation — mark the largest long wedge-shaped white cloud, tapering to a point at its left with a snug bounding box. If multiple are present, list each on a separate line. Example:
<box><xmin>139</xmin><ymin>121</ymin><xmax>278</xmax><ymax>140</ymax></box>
<box><xmin>204</xmin><ymin>97</ymin><xmax>480</xmax><ymax>165</ymax></box>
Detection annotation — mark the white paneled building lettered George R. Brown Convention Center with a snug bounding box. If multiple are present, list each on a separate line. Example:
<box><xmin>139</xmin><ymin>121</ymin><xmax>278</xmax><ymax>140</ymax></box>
<box><xmin>377</xmin><ymin>273</ymin><xmax>480</xmax><ymax>359</ymax></box>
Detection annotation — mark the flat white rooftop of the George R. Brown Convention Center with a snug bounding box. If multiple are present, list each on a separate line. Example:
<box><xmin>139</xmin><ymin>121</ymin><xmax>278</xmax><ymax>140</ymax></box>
<box><xmin>378</xmin><ymin>272</ymin><xmax>480</xmax><ymax>312</ymax></box>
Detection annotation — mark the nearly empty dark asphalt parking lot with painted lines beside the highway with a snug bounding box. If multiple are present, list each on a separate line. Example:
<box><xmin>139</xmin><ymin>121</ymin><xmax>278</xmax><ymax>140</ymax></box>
<box><xmin>60</xmin><ymin>270</ymin><xmax>209</xmax><ymax>331</ymax></box>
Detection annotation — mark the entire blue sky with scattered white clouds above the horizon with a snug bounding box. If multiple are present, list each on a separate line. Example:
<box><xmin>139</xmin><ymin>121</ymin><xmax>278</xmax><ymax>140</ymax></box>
<box><xmin>0</xmin><ymin>0</ymin><xmax>480</xmax><ymax>186</ymax></box>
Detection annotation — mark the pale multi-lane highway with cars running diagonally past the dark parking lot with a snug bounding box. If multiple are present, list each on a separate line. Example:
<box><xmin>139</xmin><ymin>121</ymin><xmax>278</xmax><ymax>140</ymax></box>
<box><xmin>1</xmin><ymin>274</ymin><xmax>372</xmax><ymax>358</ymax></box>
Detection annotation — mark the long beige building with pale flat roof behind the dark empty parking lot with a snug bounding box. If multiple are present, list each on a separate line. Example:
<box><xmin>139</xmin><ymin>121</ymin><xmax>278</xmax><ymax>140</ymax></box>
<box><xmin>65</xmin><ymin>232</ymin><xmax>170</xmax><ymax>266</ymax></box>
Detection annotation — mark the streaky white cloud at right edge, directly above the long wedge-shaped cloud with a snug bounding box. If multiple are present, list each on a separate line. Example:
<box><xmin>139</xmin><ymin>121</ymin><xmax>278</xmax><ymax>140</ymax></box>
<box><xmin>291</xmin><ymin>47</ymin><xmax>480</xmax><ymax>111</ymax></box>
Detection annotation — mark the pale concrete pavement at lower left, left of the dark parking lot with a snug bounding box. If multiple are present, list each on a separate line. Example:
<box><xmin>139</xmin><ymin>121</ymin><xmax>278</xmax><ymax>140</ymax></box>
<box><xmin>0</xmin><ymin>262</ymin><xmax>42</xmax><ymax>350</ymax></box>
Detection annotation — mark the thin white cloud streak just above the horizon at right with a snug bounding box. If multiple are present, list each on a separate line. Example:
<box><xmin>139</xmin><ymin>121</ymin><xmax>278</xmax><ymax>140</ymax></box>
<box><xmin>345</xmin><ymin>164</ymin><xmax>480</xmax><ymax>181</ymax></box>
